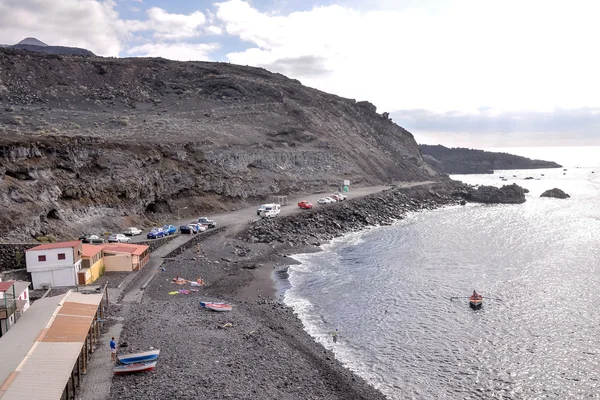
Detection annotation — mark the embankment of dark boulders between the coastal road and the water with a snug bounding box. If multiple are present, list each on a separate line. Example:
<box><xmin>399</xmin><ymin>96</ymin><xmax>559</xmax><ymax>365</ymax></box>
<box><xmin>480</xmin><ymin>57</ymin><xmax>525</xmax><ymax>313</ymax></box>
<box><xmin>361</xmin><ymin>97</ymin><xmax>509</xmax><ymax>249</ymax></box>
<box><xmin>243</xmin><ymin>181</ymin><xmax>462</xmax><ymax>246</ymax></box>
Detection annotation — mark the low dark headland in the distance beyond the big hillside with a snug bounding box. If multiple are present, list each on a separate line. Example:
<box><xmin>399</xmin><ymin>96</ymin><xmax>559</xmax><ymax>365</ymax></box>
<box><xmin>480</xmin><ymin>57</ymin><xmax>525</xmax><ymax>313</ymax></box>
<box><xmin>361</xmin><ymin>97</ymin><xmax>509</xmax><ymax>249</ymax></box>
<box><xmin>419</xmin><ymin>144</ymin><xmax>561</xmax><ymax>174</ymax></box>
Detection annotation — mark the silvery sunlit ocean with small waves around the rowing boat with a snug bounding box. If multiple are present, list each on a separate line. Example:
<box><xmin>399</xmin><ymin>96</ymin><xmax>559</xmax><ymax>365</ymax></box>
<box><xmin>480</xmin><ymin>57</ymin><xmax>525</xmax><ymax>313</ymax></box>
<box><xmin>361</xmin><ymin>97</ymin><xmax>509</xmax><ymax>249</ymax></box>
<box><xmin>283</xmin><ymin>147</ymin><xmax>600</xmax><ymax>399</ymax></box>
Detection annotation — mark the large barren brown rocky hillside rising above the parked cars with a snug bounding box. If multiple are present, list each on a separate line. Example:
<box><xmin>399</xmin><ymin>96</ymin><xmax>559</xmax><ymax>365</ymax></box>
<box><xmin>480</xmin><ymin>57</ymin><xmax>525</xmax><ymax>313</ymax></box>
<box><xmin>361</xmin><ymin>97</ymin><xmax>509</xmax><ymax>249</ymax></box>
<box><xmin>0</xmin><ymin>48</ymin><xmax>437</xmax><ymax>240</ymax></box>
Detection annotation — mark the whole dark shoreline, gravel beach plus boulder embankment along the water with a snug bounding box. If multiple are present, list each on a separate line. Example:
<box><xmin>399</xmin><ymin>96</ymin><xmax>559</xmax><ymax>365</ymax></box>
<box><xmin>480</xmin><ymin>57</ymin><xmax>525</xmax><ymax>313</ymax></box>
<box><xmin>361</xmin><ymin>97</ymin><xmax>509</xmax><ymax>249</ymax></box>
<box><xmin>110</xmin><ymin>183</ymin><xmax>464</xmax><ymax>400</ymax></box>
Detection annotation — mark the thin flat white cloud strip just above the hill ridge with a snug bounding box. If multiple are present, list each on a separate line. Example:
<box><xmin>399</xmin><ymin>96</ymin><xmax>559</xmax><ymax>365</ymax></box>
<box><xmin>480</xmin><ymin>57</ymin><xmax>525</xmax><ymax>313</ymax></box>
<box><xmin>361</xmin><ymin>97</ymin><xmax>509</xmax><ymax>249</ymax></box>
<box><xmin>127</xmin><ymin>43</ymin><xmax>219</xmax><ymax>61</ymax></box>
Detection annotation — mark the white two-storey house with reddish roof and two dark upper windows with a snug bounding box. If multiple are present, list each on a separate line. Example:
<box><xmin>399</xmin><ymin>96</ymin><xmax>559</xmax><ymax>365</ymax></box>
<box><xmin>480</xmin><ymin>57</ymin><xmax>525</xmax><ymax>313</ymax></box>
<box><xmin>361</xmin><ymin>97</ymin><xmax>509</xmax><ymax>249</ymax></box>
<box><xmin>25</xmin><ymin>240</ymin><xmax>83</xmax><ymax>289</ymax></box>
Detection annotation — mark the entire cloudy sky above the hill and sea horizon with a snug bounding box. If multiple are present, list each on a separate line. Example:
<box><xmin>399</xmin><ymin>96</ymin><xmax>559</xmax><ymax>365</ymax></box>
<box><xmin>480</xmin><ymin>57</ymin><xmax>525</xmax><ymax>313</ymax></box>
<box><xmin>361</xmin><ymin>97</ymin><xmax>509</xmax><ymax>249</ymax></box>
<box><xmin>0</xmin><ymin>0</ymin><xmax>600</xmax><ymax>147</ymax></box>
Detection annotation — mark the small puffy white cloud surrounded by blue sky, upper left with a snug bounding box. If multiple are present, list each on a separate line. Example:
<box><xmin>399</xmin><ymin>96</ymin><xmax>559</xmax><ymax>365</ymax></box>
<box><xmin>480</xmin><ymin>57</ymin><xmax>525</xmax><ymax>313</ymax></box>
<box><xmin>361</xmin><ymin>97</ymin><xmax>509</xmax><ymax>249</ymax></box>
<box><xmin>145</xmin><ymin>7</ymin><xmax>206</xmax><ymax>40</ymax></box>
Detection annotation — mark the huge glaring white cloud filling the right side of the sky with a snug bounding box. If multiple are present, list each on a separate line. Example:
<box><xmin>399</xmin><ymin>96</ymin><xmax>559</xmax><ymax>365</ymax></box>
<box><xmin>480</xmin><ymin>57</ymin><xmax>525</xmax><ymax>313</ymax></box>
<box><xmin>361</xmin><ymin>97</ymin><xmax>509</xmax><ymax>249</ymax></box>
<box><xmin>216</xmin><ymin>0</ymin><xmax>600</xmax><ymax>112</ymax></box>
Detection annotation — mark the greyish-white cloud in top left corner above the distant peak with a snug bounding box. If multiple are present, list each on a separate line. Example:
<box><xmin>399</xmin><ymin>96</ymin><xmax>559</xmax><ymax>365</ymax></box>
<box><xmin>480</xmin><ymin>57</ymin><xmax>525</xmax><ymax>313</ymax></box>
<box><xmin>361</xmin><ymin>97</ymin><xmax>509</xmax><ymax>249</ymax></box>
<box><xmin>0</xmin><ymin>0</ymin><xmax>126</xmax><ymax>56</ymax></box>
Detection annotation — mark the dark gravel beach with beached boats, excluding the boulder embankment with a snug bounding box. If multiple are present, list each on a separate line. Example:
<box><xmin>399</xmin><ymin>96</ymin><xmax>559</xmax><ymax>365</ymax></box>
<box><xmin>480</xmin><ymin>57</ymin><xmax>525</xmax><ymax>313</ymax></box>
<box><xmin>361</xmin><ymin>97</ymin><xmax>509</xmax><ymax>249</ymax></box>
<box><xmin>110</xmin><ymin>235</ymin><xmax>385</xmax><ymax>399</ymax></box>
